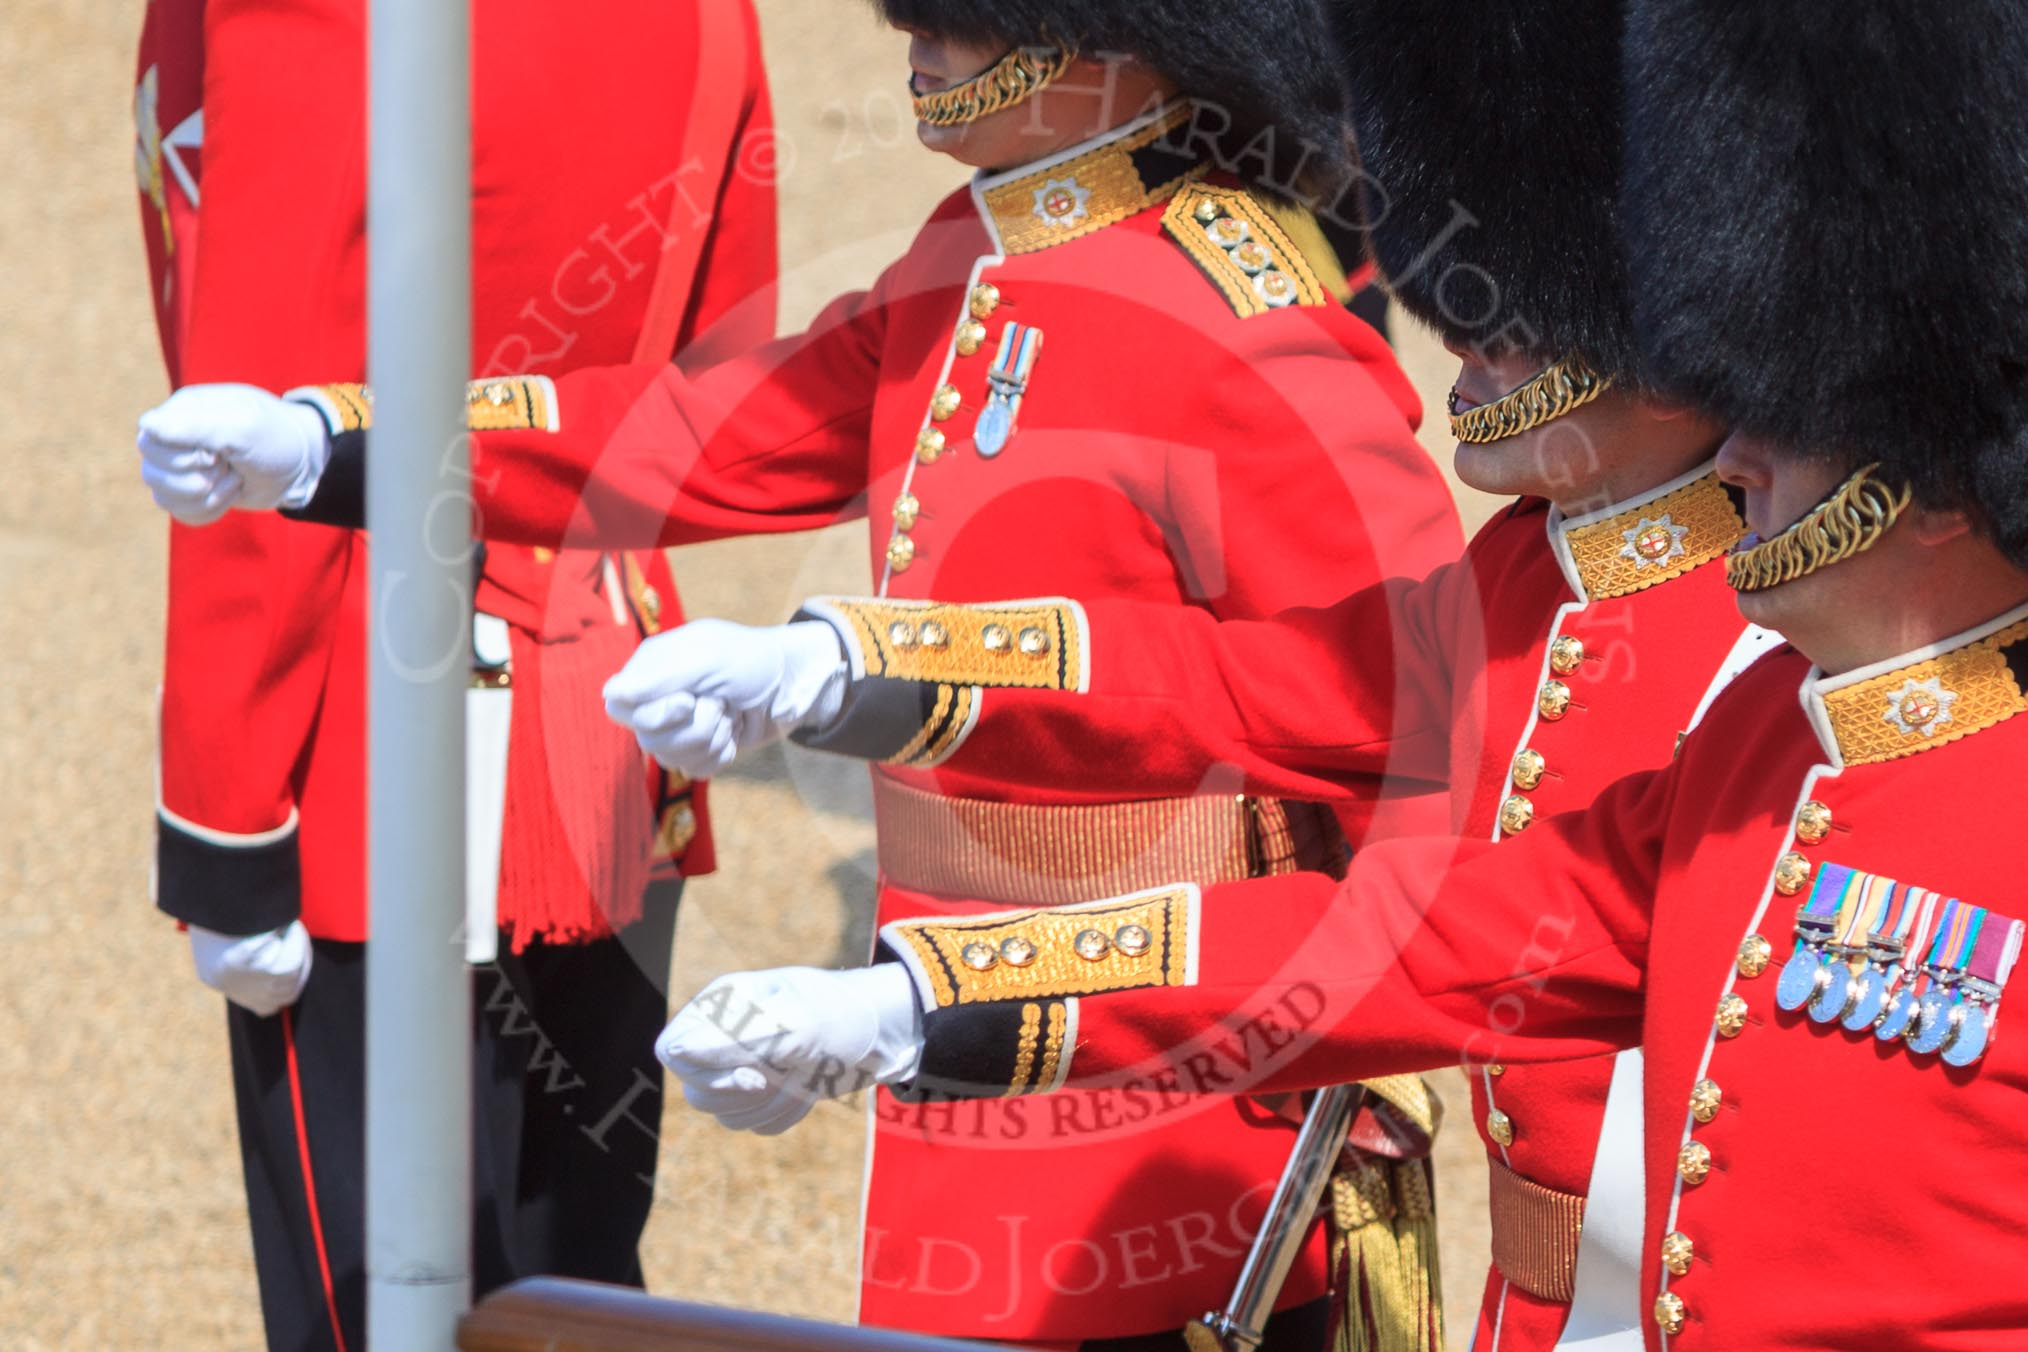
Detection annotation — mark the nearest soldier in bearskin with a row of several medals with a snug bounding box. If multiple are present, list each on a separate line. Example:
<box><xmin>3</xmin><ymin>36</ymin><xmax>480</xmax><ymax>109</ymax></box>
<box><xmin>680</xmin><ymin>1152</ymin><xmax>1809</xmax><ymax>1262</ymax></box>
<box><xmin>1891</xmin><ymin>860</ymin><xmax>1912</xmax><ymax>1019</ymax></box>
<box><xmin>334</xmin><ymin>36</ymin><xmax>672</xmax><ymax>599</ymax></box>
<box><xmin>665</xmin><ymin>0</ymin><xmax>2028</xmax><ymax>1350</ymax></box>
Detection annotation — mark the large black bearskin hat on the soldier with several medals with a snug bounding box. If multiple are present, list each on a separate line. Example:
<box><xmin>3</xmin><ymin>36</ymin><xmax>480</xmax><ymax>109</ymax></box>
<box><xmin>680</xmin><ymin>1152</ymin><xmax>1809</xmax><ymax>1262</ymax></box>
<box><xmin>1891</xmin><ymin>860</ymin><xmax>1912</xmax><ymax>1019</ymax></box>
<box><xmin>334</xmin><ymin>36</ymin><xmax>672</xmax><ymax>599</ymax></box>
<box><xmin>1626</xmin><ymin>0</ymin><xmax>2028</xmax><ymax>564</ymax></box>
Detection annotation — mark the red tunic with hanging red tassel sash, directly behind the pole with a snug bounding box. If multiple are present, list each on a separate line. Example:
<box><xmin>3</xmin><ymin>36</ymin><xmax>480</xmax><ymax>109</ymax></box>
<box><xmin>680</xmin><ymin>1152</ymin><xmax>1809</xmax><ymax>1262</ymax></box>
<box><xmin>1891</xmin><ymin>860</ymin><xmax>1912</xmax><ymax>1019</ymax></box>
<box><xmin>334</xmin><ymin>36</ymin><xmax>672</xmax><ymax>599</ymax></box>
<box><xmin>136</xmin><ymin>0</ymin><xmax>775</xmax><ymax>941</ymax></box>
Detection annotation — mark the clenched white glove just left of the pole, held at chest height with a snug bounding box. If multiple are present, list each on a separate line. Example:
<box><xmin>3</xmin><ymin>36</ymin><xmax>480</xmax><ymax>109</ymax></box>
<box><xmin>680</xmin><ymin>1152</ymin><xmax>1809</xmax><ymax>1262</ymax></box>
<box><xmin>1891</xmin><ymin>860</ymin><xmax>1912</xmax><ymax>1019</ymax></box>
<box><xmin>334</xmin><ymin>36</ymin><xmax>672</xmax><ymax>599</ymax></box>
<box><xmin>136</xmin><ymin>385</ymin><xmax>331</xmax><ymax>525</ymax></box>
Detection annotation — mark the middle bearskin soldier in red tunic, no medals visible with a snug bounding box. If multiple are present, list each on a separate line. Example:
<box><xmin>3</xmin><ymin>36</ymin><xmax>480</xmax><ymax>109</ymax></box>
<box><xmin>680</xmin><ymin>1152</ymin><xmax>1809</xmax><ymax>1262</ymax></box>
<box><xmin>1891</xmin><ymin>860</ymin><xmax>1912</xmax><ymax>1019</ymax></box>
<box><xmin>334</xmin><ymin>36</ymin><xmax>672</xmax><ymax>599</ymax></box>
<box><xmin>580</xmin><ymin>0</ymin><xmax>1772</xmax><ymax>1352</ymax></box>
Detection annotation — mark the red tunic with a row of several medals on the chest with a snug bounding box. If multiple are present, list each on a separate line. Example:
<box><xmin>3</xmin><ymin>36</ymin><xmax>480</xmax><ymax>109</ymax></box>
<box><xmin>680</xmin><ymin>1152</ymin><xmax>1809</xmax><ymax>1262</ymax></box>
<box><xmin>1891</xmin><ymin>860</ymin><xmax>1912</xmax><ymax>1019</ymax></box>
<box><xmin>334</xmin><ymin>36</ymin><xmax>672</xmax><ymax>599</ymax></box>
<box><xmin>886</xmin><ymin>608</ymin><xmax>2028</xmax><ymax>1352</ymax></box>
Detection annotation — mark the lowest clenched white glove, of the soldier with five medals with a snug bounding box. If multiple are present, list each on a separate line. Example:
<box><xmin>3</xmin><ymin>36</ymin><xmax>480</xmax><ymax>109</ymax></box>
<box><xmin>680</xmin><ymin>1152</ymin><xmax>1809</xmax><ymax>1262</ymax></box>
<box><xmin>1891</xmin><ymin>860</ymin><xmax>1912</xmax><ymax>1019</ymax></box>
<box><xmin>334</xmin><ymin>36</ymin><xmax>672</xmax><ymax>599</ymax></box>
<box><xmin>655</xmin><ymin>963</ymin><xmax>923</xmax><ymax>1135</ymax></box>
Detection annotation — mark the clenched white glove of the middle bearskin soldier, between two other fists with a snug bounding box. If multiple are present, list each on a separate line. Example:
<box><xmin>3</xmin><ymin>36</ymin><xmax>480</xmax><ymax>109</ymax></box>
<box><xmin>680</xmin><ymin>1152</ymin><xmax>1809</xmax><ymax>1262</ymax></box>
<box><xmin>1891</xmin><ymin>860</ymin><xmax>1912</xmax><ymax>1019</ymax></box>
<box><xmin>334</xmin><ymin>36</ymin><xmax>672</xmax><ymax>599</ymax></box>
<box><xmin>606</xmin><ymin>620</ymin><xmax>848</xmax><ymax>778</ymax></box>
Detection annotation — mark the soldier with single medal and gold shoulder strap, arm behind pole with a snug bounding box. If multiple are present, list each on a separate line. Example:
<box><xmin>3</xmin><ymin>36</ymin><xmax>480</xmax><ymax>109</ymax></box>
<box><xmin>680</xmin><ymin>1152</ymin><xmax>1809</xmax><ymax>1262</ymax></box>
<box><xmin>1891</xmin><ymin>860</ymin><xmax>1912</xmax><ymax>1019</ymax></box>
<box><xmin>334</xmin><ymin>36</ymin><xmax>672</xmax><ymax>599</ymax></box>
<box><xmin>126</xmin><ymin>0</ymin><xmax>1458</xmax><ymax>1348</ymax></box>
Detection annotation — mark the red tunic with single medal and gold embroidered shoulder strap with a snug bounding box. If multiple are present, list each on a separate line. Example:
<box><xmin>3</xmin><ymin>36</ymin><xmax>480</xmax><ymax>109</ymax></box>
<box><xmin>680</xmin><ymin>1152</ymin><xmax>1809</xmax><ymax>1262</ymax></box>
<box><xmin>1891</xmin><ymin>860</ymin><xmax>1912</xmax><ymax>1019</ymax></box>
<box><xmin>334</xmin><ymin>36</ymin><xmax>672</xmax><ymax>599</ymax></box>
<box><xmin>290</xmin><ymin>103</ymin><xmax>1458</xmax><ymax>1340</ymax></box>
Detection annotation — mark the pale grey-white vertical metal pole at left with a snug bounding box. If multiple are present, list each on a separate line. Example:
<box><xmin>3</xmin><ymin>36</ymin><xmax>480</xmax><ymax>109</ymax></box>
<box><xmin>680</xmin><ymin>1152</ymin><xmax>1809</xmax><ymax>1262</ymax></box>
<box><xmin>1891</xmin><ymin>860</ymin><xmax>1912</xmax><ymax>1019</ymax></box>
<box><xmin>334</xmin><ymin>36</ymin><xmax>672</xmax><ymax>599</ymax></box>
<box><xmin>367</xmin><ymin>0</ymin><xmax>473</xmax><ymax>1352</ymax></box>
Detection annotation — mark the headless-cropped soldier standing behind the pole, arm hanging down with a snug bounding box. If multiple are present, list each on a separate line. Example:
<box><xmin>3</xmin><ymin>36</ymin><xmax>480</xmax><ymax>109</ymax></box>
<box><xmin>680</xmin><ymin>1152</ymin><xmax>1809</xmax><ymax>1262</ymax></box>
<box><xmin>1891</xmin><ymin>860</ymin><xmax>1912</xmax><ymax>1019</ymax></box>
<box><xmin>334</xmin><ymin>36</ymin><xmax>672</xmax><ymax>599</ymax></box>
<box><xmin>136</xmin><ymin>0</ymin><xmax>775</xmax><ymax>1348</ymax></box>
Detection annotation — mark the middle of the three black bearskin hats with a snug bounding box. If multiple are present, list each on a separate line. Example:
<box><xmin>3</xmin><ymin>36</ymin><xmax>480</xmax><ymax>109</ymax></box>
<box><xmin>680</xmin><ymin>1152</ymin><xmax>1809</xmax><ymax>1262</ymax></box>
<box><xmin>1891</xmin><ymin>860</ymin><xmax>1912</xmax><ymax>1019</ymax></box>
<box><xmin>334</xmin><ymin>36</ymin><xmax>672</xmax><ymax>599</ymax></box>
<box><xmin>1336</xmin><ymin>0</ymin><xmax>1643</xmax><ymax>385</ymax></box>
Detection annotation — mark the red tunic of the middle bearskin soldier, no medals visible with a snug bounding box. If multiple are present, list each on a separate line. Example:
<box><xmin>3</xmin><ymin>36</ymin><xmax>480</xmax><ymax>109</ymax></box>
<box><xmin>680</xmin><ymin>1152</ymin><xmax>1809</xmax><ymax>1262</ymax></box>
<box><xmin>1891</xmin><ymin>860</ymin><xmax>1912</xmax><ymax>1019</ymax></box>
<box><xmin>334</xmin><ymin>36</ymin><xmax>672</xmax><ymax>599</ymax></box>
<box><xmin>786</xmin><ymin>468</ymin><xmax>1760</xmax><ymax>1352</ymax></box>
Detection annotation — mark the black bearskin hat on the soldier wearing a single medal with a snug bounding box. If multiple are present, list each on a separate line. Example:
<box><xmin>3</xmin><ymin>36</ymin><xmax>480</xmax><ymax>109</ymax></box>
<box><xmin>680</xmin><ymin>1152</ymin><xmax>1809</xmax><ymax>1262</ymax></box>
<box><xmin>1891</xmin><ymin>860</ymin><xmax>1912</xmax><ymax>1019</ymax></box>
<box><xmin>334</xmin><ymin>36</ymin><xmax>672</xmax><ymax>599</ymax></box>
<box><xmin>874</xmin><ymin>0</ymin><xmax>1351</xmax><ymax>197</ymax></box>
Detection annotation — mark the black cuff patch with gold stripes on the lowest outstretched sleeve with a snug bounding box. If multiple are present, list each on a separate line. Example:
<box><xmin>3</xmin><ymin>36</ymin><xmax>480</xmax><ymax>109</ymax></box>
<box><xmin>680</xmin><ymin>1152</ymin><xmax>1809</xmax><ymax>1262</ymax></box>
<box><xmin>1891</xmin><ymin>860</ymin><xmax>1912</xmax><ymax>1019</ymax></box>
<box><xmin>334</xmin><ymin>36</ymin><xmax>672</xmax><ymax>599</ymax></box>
<box><xmin>874</xmin><ymin>941</ymin><xmax>1071</xmax><ymax>1103</ymax></box>
